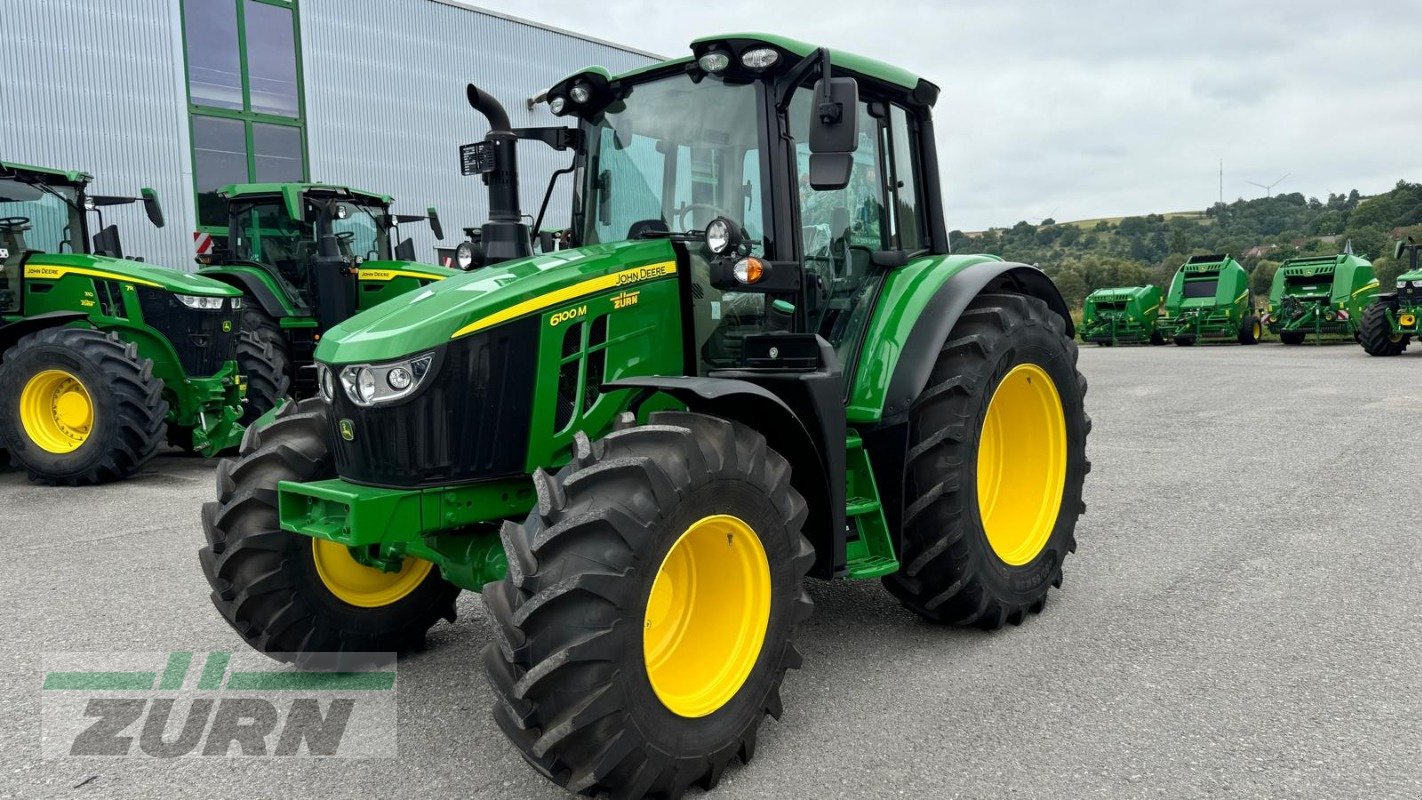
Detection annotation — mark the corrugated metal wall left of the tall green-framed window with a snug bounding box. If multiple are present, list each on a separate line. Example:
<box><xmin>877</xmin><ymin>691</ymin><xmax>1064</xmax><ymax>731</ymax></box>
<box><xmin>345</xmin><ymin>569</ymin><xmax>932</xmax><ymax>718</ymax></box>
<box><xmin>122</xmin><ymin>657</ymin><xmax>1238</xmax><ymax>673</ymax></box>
<box><xmin>0</xmin><ymin>0</ymin><xmax>193</xmax><ymax>267</ymax></box>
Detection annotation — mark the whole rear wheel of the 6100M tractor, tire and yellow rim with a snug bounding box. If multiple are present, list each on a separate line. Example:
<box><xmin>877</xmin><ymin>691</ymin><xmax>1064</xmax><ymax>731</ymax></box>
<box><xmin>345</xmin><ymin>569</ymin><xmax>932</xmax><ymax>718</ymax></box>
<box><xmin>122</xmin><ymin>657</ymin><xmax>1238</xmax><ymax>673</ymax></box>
<box><xmin>884</xmin><ymin>294</ymin><xmax>1091</xmax><ymax>629</ymax></box>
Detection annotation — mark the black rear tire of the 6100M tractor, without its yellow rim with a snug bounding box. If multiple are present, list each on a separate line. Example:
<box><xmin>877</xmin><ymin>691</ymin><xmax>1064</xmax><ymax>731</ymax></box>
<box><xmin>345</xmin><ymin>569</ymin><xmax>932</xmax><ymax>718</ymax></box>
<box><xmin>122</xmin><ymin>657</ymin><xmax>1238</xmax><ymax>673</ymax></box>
<box><xmin>884</xmin><ymin>294</ymin><xmax>1091</xmax><ymax>629</ymax></box>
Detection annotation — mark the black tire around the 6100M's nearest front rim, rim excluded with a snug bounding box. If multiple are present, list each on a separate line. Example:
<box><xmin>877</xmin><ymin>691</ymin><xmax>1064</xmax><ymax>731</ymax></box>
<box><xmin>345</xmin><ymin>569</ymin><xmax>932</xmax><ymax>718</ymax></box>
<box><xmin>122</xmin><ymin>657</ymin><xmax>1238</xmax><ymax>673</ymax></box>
<box><xmin>483</xmin><ymin>412</ymin><xmax>815</xmax><ymax>799</ymax></box>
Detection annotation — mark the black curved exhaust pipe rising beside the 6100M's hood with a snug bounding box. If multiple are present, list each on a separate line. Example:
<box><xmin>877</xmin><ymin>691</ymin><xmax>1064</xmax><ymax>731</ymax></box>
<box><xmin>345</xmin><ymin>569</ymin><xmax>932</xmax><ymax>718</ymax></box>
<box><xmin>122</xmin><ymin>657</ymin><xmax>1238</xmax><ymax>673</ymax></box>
<box><xmin>465</xmin><ymin>84</ymin><xmax>533</xmax><ymax>264</ymax></box>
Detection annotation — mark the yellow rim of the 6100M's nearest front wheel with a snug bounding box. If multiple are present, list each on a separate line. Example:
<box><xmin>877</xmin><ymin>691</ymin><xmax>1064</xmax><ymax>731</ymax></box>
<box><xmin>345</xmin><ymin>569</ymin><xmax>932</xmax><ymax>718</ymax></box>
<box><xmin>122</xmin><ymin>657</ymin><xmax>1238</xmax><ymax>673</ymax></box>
<box><xmin>641</xmin><ymin>514</ymin><xmax>771</xmax><ymax>718</ymax></box>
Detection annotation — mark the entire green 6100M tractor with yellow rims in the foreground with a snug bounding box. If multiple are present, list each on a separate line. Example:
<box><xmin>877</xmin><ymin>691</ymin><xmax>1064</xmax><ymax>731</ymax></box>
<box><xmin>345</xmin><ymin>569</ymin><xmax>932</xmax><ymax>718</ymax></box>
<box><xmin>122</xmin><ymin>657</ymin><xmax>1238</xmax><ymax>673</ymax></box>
<box><xmin>201</xmin><ymin>34</ymin><xmax>1091</xmax><ymax>799</ymax></box>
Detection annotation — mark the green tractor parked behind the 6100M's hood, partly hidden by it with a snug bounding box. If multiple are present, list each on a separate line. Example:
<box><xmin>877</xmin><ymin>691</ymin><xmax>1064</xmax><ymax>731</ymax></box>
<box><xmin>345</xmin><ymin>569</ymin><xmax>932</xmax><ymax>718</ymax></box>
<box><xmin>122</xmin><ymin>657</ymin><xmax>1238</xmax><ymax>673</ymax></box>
<box><xmin>198</xmin><ymin>183</ymin><xmax>458</xmax><ymax>423</ymax></box>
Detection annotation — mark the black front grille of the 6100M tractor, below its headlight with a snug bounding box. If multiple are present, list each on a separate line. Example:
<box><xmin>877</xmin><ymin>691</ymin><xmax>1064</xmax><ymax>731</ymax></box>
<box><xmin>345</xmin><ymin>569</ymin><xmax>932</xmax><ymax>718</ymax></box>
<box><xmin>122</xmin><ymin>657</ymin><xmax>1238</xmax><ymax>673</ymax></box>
<box><xmin>331</xmin><ymin>317</ymin><xmax>539</xmax><ymax>487</ymax></box>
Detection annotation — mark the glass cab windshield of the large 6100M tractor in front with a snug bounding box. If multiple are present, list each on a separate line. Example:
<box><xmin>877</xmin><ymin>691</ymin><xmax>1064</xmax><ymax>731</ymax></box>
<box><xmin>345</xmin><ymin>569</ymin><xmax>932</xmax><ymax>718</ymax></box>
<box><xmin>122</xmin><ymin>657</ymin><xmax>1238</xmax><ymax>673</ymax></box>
<box><xmin>580</xmin><ymin>74</ymin><xmax>765</xmax><ymax>252</ymax></box>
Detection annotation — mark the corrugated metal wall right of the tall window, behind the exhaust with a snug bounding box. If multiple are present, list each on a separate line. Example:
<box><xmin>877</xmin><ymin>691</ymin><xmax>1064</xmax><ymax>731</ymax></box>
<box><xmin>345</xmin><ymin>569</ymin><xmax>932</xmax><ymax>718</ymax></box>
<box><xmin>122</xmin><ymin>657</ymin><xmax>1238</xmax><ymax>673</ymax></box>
<box><xmin>301</xmin><ymin>0</ymin><xmax>653</xmax><ymax>260</ymax></box>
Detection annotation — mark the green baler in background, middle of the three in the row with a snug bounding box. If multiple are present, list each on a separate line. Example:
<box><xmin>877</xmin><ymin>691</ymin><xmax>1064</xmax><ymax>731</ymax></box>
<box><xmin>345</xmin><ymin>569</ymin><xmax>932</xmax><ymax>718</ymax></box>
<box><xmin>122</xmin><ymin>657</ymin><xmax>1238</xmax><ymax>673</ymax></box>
<box><xmin>1160</xmin><ymin>256</ymin><xmax>1264</xmax><ymax>347</ymax></box>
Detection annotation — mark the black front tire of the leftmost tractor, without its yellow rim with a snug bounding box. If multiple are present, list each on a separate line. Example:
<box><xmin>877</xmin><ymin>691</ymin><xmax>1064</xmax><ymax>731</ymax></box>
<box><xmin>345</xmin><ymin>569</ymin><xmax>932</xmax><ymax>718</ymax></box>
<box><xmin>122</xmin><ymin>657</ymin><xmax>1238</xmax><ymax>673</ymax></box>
<box><xmin>0</xmin><ymin>328</ymin><xmax>168</xmax><ymax>486</ymax></box>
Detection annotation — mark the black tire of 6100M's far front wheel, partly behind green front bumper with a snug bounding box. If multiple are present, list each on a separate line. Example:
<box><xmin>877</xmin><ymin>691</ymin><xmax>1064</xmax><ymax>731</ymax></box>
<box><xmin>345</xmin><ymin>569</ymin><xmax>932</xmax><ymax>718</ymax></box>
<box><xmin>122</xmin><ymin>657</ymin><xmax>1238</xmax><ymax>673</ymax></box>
<box><xmin>198</xmin><ymin>399</ymin><xmax>459</xmax><ymax>668</ymax></box>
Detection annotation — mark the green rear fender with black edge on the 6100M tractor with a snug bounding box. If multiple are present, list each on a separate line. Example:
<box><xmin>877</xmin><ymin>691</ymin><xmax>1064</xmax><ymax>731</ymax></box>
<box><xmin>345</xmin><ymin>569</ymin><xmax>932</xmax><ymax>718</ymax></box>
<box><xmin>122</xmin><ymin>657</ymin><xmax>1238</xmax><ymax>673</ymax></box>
<box><xmin>846</xmin><ymin>256</ymin><xmax>1076</xmax><ymax>423</ymax></box>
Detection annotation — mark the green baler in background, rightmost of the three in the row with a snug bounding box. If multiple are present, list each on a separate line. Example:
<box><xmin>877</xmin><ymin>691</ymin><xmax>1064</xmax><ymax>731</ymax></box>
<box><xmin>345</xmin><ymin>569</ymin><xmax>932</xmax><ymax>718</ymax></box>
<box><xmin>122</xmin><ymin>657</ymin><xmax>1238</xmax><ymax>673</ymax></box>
<box><xmin>1264</xmin><ymin>253</ymin><xmax>1378</xmax><ymax>344</ymax></box>
